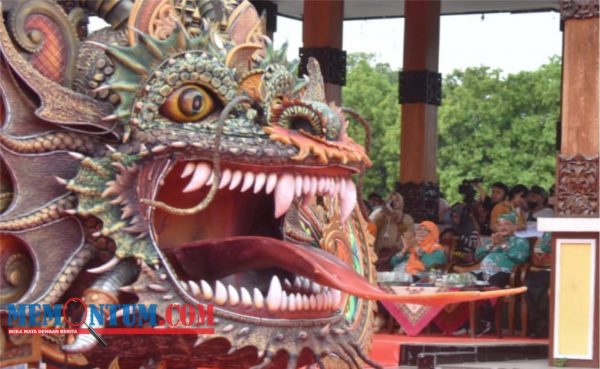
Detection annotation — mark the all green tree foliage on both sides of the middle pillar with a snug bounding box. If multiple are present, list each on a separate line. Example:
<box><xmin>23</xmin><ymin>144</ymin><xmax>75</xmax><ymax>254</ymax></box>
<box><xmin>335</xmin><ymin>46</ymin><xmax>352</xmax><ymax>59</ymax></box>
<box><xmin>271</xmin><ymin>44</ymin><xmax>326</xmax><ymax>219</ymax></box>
<box><xmin>342</xmin><ymin>53</ymin><xmax>561</xmax><ymax>203</ymax></box>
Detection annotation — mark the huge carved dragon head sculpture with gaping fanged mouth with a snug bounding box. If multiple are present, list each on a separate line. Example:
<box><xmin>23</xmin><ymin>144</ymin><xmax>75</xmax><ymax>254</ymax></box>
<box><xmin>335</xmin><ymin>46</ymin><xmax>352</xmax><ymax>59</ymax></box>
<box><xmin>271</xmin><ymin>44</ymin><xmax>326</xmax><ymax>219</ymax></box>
<box><xmin>0</xmin><ymin>0</ymin><xmax>524</xmax><ymax>368</ymax></box>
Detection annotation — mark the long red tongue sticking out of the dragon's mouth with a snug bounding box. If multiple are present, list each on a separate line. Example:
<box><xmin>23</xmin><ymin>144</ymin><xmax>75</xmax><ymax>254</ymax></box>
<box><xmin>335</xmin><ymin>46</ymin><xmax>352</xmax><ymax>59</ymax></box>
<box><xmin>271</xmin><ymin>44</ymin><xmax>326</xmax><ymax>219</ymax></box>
<box><xmin>174</xmin><ymin>236</ymin><xmax>525</xmax><ymax>304</ymax></box>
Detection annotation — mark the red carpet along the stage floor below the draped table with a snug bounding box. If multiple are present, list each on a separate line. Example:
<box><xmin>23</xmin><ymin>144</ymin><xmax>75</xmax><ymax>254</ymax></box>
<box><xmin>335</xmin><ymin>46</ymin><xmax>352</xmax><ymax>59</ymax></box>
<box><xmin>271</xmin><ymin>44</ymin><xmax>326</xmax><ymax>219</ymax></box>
<box><xmin>370</xmin><ymin>334</ymin><xmax>548</xmax><ymax>367</ymax></box>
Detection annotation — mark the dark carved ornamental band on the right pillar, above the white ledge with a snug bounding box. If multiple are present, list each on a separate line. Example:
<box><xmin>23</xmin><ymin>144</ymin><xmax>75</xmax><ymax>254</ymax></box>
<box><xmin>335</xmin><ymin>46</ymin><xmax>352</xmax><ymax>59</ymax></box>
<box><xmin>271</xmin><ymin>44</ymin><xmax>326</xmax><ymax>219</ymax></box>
<box><xmin>556</xmin><ymin>155</ymin><xmax>599</xmax><ymax>217</ymax></box>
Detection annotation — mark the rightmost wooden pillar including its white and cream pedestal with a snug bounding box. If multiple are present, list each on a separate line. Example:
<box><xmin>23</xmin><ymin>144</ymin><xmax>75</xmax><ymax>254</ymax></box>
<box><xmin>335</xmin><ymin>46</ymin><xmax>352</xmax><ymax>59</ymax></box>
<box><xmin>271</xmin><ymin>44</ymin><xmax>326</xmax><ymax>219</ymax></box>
<box><xmin>538</xmin><ymin>0</ymin><xmax>600</xmax><ymax>367</ymax></box>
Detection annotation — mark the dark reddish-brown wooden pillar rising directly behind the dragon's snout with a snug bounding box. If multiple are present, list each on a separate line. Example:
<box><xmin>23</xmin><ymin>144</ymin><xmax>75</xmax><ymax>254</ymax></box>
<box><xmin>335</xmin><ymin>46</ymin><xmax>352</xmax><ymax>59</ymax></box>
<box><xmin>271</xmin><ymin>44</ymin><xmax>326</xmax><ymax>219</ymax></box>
<box><xmin>300</xmin><ymin>0</ymin><xmax>346</xmax><ymax>105</ymax></box>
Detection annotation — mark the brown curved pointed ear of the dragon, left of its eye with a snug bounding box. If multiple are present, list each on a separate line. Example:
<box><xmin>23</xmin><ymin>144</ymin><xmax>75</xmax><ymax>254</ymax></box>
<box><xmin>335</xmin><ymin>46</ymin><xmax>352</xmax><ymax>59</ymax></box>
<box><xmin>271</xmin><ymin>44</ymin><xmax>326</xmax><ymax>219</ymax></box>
<box><xmin>0</xmin><ymin>17</ymin><xmax>114</xmax><ymax>132</ymax></box>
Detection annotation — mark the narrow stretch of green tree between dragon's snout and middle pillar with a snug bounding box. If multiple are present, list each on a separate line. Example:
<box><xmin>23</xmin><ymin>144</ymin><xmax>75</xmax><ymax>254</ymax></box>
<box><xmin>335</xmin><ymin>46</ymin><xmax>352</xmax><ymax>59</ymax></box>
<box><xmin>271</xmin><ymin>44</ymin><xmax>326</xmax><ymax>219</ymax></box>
<box><xmin>342</xmin><ymin>53</ymin><xmax>400</xmax><ymax>197</ymax></box>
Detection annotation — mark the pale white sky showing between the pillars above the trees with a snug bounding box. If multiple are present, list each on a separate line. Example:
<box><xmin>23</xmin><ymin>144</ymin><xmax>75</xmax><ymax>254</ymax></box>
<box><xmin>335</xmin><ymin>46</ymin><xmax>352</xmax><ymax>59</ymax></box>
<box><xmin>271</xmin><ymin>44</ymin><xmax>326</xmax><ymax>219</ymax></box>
<box><xmin>273</xmin><ymin>12</ymin><xmax>562</xmax><ymax>74</ymax></box>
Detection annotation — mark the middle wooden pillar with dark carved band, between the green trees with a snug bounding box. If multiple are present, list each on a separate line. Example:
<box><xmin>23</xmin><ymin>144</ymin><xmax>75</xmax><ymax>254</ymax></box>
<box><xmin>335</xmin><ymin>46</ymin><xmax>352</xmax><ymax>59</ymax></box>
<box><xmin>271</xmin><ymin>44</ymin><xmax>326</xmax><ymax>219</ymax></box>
<box><xmin>396</xmin><ymin>0</ymin><xmax>441</xmax><ymax>221</ymax></box>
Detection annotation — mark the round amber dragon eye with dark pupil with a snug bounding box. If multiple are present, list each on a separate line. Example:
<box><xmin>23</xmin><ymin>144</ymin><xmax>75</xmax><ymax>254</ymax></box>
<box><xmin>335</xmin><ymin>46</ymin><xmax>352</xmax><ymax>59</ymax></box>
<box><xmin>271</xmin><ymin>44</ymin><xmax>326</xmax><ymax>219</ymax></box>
<box><xmin>160</xmin><ymin>85</ymin><xmax>215</xmax><ymax>123</ymax></box>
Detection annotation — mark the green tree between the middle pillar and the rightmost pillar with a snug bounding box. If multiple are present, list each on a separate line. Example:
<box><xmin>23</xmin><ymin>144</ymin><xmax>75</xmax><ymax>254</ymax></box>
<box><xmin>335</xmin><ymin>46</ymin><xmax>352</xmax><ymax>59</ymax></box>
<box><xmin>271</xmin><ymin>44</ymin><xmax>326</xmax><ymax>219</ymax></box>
<box><xmin>438</xmin><ymin>57</ymin><xmax>561</xmax><ymax>203</ymax></box>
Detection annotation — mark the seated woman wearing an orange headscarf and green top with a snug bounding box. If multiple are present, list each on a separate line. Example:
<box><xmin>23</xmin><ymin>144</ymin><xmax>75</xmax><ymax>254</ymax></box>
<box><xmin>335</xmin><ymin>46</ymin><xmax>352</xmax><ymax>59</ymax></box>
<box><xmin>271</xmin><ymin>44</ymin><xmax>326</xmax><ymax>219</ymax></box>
<box><xmin>390</xmin><ymin>221</ymin><xmax>446</xmax><ymax>276</ymax></box>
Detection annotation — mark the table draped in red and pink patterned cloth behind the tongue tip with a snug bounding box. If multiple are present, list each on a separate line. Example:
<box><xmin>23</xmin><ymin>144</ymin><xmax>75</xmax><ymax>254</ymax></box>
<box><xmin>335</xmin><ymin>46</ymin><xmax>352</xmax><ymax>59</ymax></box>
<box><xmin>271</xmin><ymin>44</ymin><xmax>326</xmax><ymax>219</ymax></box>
<box><xmin>381</xmin><ymin>285</ymin><xmax>502</xmax><ymax>338</ymax></box>
